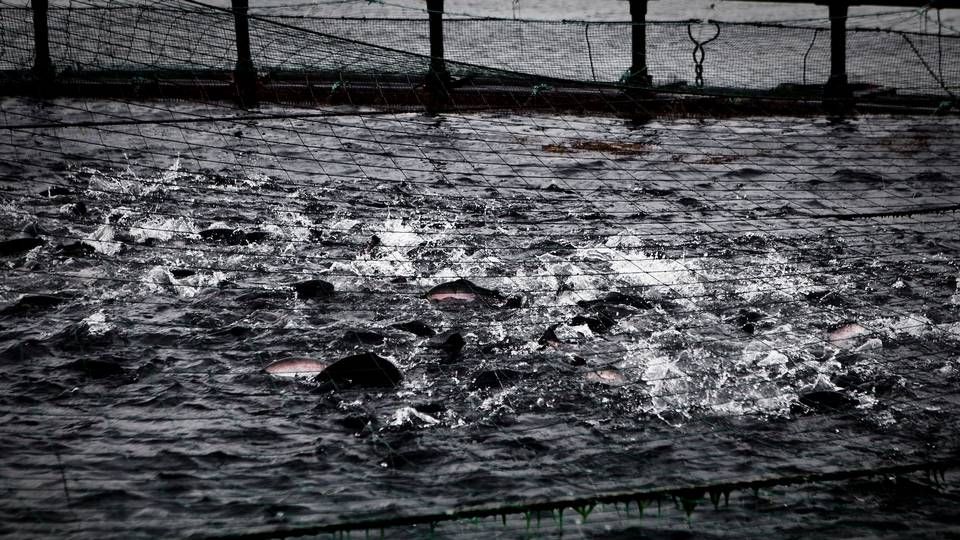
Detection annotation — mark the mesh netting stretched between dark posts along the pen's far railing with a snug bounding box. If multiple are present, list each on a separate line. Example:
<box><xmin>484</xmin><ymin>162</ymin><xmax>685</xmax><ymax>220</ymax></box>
<box><xmin>0</xmin><ymin>2</ymin><xmax>960</xmax><ymax>96</ymax></box>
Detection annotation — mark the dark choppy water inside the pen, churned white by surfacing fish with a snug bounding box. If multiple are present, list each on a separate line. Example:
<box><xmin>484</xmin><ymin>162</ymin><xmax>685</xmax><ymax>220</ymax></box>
<box><xmin>0</xmin><ymin>100</ymin><xmax>960</xmax><ymax>538</ymax></box>
